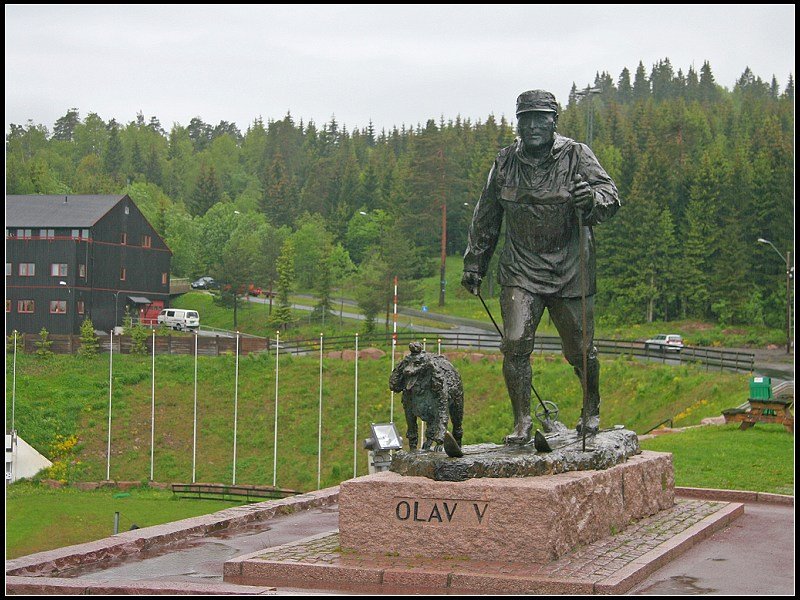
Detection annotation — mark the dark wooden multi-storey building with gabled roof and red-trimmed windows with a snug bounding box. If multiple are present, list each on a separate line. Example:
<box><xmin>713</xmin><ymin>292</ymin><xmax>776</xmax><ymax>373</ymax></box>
<box><xmin>6</xmin><ymin>195</ymin><xmax>172</xmax><ymax>334</ymax></box>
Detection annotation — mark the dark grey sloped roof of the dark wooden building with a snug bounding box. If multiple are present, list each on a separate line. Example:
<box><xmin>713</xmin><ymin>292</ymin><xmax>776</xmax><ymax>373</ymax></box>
<box><xmin>6</xmin><ymin>194</ymin><xmax>126</xmax><ymax>227</ymax></box>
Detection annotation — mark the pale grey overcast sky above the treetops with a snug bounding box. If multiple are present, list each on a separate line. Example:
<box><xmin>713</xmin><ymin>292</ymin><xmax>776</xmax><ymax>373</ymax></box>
<box><xmin>5</xmin><ymin>4</ymin><xmax>795</xmax><ymax>132</ymax></box>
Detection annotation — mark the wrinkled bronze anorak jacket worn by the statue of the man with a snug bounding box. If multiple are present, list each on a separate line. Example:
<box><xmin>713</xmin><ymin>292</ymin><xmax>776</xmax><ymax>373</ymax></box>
<box><xmin>464</xmin><ymin>134</ymin><xmax>620</xmax><ymax>298</ymax></box>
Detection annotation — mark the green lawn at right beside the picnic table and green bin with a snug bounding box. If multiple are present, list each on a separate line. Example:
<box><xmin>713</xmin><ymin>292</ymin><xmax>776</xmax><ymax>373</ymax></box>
<box><xmin>641</xmin><ymin>423</ymin><xmax>794</xmax><ymax>494</ymax></box>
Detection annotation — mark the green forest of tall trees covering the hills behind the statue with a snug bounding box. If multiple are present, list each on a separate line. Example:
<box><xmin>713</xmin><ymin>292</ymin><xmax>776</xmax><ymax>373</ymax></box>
<box><xmin>6</xmin><ymin>58</ymin><xmax>794</xmax><ymax>328</ymax></box>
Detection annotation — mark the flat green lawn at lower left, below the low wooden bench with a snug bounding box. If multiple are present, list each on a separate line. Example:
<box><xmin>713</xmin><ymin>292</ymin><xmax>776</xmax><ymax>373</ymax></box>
<box><xmin>6</xmin><ymin>481</ymin><xmax>241</xmax><ymax>559</ymax></box>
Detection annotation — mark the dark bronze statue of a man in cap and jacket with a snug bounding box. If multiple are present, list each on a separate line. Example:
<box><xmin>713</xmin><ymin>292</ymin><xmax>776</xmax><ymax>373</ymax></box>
<box><xmin>461</xmin><ymin>90</ymin><xmax>620</xmax><ymax>444</ymax></box>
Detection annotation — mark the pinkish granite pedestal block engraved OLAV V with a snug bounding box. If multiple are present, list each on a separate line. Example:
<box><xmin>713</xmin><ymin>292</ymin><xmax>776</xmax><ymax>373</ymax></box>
<box><xmin>339</xmin><ymin>451</ymin><xmax>674</xmax><ymax>563</ymax></box>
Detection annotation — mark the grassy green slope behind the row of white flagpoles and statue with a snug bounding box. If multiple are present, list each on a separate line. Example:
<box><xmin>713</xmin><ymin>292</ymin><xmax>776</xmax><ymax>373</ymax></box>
<box><xmin>6</xmin><ymin>354</ymin><xmax>748</xmax><ymax>491</ymax></box>
